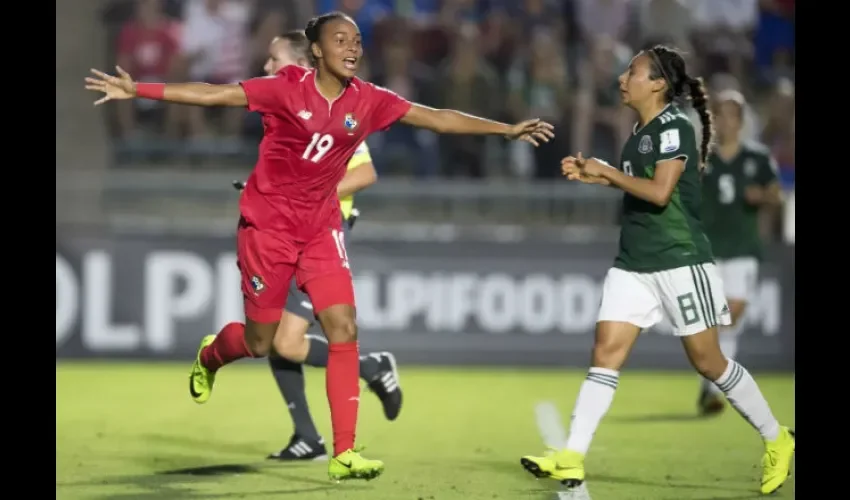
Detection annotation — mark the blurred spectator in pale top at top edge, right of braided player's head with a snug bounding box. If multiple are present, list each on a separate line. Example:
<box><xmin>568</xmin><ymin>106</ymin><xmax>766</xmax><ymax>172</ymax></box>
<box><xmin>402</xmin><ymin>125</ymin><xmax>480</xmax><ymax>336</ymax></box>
<box><xmin>691</xmin><ymin>0</ymin><xmax>758</xmax><ymax>81</ymax></box>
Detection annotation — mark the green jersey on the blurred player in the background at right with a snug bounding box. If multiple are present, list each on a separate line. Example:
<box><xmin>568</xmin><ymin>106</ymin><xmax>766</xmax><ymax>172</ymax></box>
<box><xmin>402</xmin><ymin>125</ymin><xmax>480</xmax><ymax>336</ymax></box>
<box><xmin>702</xmin><ymin>140</ymin><xmax>776</xmax><ymax>259</ymax></box>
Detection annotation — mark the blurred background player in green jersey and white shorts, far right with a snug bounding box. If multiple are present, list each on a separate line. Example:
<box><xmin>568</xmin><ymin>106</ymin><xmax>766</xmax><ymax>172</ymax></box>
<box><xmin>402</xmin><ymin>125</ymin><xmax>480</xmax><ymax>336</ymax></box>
<box><xmin>697</xmin><ymin>90</ymin><xmax>782</xmax><ymax>415</ymax></box>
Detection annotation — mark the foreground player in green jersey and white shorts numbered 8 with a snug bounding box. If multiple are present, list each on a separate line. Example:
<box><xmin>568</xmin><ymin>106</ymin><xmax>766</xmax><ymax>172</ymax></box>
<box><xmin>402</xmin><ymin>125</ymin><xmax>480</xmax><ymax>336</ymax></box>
<box><xmin>521</xmin><ymin>46</ymin><xmax>795</xmax><ymax>494</ymax></box>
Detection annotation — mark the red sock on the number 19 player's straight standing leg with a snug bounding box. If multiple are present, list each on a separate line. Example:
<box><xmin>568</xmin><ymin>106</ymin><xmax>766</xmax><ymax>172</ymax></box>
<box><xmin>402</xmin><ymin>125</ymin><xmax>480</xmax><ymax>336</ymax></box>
<box><xmin>325</xmin><ymin>342</ymin><xmax>360</xmax><ymax>456</ymax></box>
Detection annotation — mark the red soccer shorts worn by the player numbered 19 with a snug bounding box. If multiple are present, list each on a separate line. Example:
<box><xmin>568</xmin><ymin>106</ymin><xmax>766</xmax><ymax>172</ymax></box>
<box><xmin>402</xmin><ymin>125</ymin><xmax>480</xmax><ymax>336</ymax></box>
<box><xmin>236</xmin><ymin>224</ymin><xmax>354</xmax><ymax>323</ymax></box>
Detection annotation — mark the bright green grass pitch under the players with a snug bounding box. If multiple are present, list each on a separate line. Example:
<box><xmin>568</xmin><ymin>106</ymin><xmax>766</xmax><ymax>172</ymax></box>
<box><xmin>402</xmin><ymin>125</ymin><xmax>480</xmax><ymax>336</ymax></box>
<box><xmin>56</xmin><ymin>362</ymin><xmax>794</xmax><ymax>500</ymax></box>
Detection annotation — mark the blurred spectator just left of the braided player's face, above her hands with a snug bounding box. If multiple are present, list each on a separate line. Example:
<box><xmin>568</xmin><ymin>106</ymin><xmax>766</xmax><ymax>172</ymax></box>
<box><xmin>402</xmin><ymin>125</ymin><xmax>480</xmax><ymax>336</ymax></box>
<box><xmin>572</xmin><ymin>38</ymin><xmax>634</xmax><ymax>164</ymax></box>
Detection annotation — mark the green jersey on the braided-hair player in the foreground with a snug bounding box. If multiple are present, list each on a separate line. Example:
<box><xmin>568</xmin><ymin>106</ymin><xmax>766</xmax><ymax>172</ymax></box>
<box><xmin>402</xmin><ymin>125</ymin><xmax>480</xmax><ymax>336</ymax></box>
<box><xmin>614</xmin><ymin>104</ymin><xmax>713</xmax><ymax>272</ymax></box>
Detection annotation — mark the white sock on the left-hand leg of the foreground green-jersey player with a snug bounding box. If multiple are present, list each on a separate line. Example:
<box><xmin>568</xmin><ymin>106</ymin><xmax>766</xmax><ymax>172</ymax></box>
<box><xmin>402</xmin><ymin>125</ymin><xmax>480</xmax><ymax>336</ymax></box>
<box><xmin>566</xmin><ymin>368</ymin><xmax>620</xmax><ymax>455</ymax></box>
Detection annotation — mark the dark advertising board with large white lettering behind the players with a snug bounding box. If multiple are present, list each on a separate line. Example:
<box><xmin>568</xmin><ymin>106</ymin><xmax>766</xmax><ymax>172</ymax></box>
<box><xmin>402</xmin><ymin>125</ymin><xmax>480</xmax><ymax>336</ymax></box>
<box><xmin>56</xmin><ymin>230</ymin><xmax>795</xmax><ymax>370</ymax></box>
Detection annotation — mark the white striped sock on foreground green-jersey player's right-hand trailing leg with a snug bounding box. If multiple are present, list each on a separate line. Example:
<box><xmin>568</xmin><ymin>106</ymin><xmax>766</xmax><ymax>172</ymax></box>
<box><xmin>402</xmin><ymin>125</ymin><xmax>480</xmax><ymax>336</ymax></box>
<box><xmin>714</xmin><ymin>360</ymin><xmax>779</xmax><ymax>441</ymax></box>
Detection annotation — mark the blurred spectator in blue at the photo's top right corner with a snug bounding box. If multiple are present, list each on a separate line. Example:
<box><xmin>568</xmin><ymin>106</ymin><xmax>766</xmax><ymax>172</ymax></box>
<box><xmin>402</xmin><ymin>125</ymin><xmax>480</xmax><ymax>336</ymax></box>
<box><xmin>755</xmin><ymin>0</ymin><xmax>796</xmax><ymax>81</ymax></box>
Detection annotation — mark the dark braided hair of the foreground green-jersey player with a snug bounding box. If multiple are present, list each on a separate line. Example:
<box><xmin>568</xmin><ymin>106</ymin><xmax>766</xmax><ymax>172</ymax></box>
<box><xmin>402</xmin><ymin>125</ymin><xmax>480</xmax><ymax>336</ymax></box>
<box><xmin>646</xmin><ymin>45</ymin><xmax>714</xmax><ymax>170</ymax></box>
